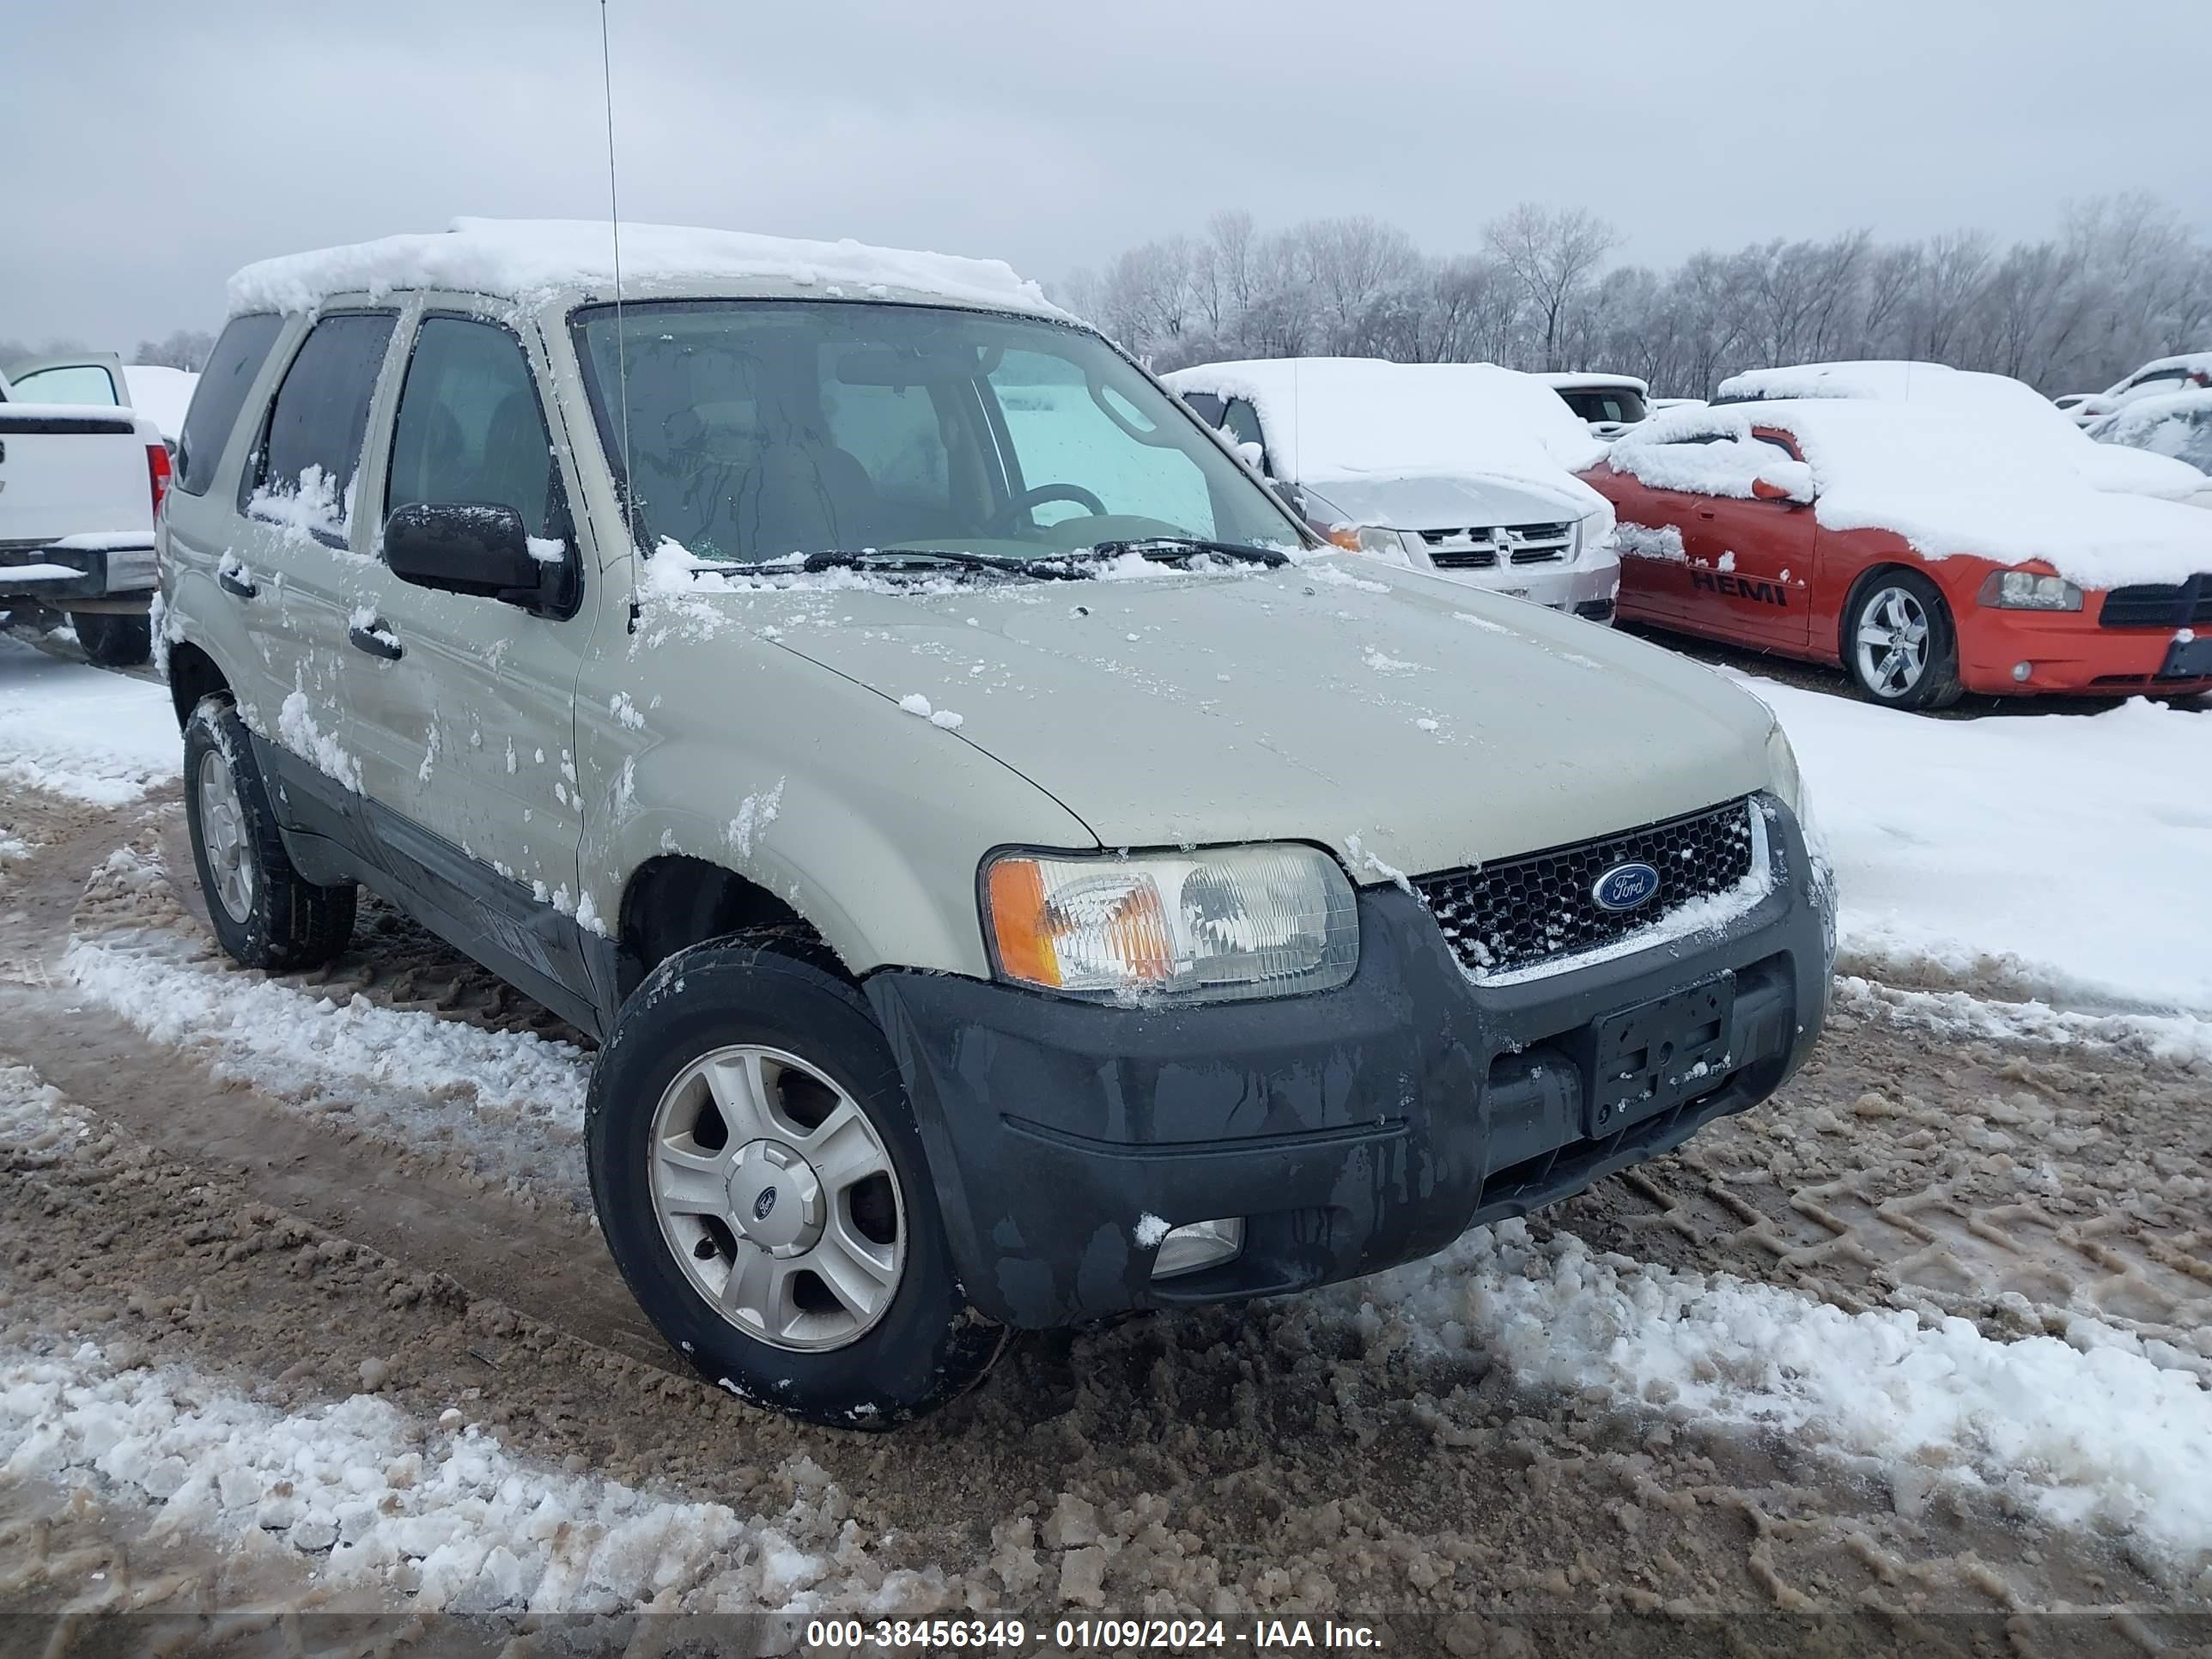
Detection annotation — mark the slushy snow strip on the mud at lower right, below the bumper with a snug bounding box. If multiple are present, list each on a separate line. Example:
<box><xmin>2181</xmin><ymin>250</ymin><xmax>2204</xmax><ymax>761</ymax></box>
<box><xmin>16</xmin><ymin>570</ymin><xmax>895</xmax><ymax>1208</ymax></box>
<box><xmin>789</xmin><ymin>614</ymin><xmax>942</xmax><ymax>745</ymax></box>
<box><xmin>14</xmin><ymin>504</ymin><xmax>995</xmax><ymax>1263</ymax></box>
<box><xmin>1316</xmin><ymin>1221</ymin><xmax>2212</xmax><ymax>1564</ymax></box>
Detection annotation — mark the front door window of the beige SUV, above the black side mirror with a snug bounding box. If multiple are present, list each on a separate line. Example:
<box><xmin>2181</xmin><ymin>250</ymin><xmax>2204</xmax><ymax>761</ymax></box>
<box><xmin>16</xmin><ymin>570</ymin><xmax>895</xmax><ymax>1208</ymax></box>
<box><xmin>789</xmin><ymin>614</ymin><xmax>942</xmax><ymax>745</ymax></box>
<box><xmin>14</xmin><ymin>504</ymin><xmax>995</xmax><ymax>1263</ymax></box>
<box><xmin>385</xmin><ymin>316</ymin><xmax>566</xmax><ymax>540</ymax></box>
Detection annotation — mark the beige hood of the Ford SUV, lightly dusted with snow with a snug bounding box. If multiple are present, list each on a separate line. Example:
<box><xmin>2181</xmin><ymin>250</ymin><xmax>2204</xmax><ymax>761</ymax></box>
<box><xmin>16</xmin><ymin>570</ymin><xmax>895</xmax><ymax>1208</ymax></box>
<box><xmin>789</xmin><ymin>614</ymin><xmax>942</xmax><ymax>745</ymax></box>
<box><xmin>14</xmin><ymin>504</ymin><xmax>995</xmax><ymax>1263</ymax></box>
<box><xmin>730</xmin><ymin>556</ymin><xmax>1771</xmax><ymax>883</ymax></box>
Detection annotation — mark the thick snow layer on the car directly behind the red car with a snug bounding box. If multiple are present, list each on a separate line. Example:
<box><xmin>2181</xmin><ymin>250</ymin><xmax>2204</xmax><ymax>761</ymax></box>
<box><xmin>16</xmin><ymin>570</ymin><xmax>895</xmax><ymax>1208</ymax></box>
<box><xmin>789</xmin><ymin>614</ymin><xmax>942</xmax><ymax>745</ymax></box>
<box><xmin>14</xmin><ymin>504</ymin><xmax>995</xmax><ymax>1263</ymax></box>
<box><xmin>1719</xmin><ymin>361</ymin><xmax>2203</xmax><ymax>502</ymax></box>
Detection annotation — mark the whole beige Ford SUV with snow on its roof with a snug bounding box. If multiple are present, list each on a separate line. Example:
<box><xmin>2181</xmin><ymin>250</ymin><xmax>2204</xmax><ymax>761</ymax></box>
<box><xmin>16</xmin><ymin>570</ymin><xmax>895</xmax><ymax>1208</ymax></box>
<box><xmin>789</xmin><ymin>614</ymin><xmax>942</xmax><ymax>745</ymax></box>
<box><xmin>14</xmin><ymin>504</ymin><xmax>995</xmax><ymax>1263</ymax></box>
<box><xmin>161</xmin><ymin>222</ymin><xmax>1834</xmax><ymax>1427</ymax></box>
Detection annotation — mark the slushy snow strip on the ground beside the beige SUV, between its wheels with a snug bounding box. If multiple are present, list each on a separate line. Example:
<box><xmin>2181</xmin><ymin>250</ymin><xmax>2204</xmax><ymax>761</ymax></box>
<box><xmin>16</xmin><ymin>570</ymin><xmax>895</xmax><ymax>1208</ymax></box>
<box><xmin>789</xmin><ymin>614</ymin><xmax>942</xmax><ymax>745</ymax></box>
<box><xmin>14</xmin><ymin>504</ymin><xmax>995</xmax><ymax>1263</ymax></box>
<box><xmin>62</xmin><ymin>940</ymin><xmax>591</xmax><ymax>1192</ymax></box>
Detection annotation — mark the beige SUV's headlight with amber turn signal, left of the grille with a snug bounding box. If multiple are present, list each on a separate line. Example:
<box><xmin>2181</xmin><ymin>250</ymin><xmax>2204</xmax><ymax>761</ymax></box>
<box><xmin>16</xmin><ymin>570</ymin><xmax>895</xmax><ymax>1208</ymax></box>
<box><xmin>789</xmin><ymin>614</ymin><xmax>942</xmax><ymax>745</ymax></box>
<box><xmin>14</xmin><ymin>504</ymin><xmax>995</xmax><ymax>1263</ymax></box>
<box><xmin>982</xmin><ymin>845</ymin><xmax>1360</xmax><ymax>1002</ymax></box>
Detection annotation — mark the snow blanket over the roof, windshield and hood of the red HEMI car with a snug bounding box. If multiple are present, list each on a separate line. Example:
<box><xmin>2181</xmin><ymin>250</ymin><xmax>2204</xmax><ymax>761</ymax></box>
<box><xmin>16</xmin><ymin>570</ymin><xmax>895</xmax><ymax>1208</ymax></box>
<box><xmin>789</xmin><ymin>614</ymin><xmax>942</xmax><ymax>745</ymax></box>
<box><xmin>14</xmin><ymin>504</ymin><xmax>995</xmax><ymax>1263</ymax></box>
<box><xmin>1610</xmin><ymin>398</ymin><xmax>2212</xmax><ymax>588</ymax></box>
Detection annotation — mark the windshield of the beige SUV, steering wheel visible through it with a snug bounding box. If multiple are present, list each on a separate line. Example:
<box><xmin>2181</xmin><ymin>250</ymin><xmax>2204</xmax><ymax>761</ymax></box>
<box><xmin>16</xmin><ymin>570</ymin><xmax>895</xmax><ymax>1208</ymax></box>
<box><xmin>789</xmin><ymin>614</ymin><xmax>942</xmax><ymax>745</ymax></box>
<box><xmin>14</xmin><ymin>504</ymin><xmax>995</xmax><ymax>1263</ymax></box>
<box><xmin>571</xmin><ymin>301</ymin><xmax>1301</xmax><ymax>564</ymax></box>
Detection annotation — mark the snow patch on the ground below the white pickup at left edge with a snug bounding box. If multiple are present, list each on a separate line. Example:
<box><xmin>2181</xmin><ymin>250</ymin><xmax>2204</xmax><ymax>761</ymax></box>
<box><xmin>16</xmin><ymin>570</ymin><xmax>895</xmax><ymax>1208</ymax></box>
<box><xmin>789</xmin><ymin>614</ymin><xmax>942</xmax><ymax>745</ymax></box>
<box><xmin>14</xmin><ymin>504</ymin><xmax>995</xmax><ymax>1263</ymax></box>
<box><xmin>0</xmin><ymin>637</ymin><xmax>184</xmax><ymax>807</ymax></box>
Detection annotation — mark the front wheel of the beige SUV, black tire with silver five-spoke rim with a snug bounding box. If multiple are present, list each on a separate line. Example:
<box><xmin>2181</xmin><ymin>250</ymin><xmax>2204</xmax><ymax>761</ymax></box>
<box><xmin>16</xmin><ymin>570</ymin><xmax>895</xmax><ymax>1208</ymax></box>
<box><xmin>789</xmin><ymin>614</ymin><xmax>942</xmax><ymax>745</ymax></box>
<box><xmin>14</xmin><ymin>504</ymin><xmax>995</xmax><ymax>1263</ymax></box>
<box><xmin>584</xmin><ymin>936</ymin><xmax>1006</xmax><ymax>1429</ymax></box>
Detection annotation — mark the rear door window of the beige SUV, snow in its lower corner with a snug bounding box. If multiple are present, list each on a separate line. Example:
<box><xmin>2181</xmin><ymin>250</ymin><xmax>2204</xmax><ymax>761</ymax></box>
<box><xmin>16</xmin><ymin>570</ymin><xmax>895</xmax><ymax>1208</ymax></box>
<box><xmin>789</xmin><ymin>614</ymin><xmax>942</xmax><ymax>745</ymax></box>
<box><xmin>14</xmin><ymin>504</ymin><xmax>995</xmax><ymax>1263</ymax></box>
<box><xmin>239</xmin><ymin>312</ymin><xmax>396</xmax><ymax>546</ymax></box>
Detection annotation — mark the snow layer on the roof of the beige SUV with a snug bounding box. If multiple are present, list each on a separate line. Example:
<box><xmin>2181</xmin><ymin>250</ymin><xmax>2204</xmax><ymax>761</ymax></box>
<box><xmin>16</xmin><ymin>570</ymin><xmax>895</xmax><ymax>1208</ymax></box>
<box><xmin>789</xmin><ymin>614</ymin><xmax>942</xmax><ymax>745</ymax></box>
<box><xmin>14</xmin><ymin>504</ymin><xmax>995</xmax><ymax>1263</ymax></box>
<box><xmin>230</xmin><ymin>219</ymin><xmax>1061</xmax><ymax>316</ymax></box>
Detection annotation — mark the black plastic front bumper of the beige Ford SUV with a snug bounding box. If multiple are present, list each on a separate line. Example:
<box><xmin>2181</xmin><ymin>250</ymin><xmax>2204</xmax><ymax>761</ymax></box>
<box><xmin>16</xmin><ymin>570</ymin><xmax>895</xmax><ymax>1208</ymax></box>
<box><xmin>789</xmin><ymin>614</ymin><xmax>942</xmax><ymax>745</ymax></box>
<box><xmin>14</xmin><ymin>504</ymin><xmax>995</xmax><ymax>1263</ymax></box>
<box><xmin>867</xmin><ymin>805</ymin><xmax>1834</xmax><ymax>1328</ymax></box>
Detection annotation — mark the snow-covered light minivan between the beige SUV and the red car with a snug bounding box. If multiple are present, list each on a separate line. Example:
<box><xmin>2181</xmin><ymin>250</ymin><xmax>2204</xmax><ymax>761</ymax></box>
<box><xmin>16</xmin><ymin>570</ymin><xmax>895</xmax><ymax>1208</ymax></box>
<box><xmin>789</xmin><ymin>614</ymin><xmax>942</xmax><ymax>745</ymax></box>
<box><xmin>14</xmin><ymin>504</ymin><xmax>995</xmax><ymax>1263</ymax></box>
<box><xmin>1166</xmin><ymin>356</ymin><xmax>1620</xmax><ymax>622</ymax></box>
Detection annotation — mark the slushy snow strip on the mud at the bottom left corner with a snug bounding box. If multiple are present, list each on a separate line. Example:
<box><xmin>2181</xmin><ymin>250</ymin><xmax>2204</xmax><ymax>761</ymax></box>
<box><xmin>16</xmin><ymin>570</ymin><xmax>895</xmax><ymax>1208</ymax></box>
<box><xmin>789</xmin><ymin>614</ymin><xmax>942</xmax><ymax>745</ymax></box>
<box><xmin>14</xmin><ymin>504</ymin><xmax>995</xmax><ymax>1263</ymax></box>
<box><xmin>0</xmin><ymin>1343</ymin><xmax>936</xmax><ymax>1614</ymax></box>
